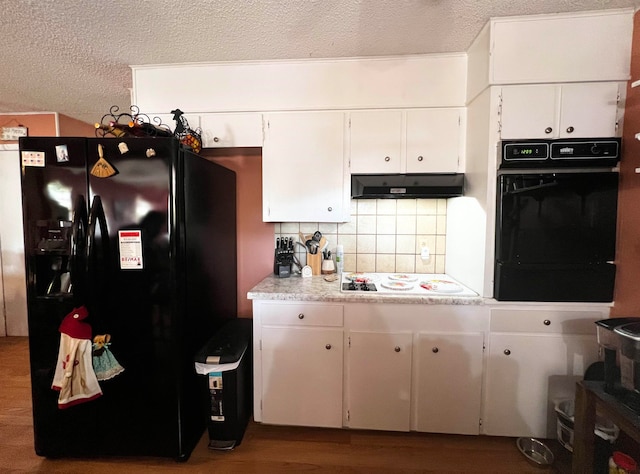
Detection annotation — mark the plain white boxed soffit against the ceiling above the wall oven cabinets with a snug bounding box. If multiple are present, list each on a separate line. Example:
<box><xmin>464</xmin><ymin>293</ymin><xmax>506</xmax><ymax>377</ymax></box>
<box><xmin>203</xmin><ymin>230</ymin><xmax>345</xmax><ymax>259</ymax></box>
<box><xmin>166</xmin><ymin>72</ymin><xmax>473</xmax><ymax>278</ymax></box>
<box><xmin>467</xmin><ymin>8</ymin><xmax>634</xmax><ymax>102</ymax></box>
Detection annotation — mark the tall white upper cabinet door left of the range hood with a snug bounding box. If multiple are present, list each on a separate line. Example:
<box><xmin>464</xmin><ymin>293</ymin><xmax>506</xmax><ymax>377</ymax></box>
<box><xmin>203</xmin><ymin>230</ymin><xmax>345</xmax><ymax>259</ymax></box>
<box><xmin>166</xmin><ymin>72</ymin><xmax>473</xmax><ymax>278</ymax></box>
<box><xmin>262</xmin><ymin>112</ymin><xmax>350</xmax><ymax>222</ymax></box>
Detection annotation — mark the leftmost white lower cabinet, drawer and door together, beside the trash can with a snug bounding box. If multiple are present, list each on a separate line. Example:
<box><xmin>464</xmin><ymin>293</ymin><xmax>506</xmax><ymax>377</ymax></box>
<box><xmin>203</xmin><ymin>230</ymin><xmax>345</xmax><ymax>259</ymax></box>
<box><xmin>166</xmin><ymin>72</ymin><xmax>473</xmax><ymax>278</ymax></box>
<box><xmin>253</xmin><ymin>301</ymin><xmax>344</xmax><ymax>428</ymax></box>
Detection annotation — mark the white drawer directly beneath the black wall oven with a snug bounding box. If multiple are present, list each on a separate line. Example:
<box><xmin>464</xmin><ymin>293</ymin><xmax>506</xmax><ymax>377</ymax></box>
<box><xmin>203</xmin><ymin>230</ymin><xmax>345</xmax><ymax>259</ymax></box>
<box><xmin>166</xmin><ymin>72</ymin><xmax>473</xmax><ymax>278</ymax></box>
<box><xmin>491</xmin><ymin>309</ymin><xmax>606</xmax><ymax>335</ymax></box>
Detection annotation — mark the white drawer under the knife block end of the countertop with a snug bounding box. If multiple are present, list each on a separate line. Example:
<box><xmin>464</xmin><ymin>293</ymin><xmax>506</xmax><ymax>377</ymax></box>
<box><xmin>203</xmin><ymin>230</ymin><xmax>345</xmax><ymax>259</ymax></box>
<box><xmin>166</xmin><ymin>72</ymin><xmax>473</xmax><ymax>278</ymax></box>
<box><xmin>260</xmin><ymin>303</ymin><xmax>344</xmax><ymax>326</ymax></box>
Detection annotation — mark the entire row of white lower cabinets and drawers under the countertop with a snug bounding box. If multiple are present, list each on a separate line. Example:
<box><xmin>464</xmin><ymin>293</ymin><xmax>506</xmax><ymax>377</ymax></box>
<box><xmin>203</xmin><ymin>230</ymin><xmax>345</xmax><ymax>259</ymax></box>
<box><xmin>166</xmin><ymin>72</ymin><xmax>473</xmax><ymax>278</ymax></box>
<box><xmin>253</xmin><ymin>300</ymin><xmax>609</xmax><ymax>438</ymax></box>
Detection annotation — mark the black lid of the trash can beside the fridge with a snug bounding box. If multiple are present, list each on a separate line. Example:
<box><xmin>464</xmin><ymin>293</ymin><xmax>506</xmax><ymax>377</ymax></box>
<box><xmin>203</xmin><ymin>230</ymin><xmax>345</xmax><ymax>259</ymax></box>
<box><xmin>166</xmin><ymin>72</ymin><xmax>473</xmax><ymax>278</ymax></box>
<box><xmin>195</xmin><ymin>318</ymin><xmax>253</xmax><ymax>364</ymax></box>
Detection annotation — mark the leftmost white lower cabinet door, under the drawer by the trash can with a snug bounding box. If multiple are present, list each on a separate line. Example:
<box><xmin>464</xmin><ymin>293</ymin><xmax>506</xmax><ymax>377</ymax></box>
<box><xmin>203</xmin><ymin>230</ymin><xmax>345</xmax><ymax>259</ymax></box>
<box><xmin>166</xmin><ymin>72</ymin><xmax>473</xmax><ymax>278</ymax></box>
<box><xmin>262</xmin><ymin>327</ymin><xmax>343</xmax><ymax>428</ymax></box>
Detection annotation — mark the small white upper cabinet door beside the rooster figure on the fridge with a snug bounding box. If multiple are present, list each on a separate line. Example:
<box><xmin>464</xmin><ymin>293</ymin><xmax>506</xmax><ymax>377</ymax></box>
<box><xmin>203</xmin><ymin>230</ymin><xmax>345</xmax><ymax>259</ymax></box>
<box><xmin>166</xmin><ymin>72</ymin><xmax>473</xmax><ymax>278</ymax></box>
<box><xmin>200</xmin><ymin>113</ymin><xmax>262</xmax><ymax>148</ymax></box>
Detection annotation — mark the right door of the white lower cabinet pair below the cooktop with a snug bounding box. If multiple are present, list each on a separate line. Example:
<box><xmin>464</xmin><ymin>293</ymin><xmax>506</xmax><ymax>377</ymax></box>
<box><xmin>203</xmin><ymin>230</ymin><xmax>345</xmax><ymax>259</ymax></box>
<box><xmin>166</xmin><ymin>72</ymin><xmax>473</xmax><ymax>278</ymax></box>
<box><xmin>414</xmin><ymin>333</ymin><xmax>484</xmax><ymax>435</ymax></box>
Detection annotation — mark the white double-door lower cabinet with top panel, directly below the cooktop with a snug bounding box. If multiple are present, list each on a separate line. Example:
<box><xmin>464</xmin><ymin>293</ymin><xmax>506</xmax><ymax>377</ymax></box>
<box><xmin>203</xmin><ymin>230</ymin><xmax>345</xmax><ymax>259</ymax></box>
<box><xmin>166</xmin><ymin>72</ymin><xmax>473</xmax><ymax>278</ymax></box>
<box><xmin>344</xmin><ymin>304</ymin><xmax>488</xmax><ymax>434</ymax></box>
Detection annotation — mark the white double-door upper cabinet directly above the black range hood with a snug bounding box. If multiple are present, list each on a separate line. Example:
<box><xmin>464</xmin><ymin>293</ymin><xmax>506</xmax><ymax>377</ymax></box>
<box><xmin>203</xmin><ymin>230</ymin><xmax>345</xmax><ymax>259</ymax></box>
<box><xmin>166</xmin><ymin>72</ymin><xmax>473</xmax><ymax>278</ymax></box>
<box><xmin>350</xmin><ymin>108</ymin><xmax>465</xmax><ymax>174</ymax></box>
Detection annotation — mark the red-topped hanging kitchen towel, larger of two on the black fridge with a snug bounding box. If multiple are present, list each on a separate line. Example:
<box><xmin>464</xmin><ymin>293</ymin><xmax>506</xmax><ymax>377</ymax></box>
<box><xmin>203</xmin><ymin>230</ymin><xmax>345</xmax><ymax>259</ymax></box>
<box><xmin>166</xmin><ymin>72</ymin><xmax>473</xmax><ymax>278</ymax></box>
<box><xmin>51</xmin><ymin>306</ymin><xmax>102</xmax><ymax>408</ymax></box>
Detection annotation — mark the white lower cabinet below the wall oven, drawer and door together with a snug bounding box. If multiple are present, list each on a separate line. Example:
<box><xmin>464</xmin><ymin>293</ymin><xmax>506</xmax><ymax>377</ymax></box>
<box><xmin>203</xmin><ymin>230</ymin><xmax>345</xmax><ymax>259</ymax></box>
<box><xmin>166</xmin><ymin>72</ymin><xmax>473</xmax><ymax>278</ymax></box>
<box><xmin>482</xmin><ymin>308</ymin><xmax>608</xmax><ymax>438</ymax></box>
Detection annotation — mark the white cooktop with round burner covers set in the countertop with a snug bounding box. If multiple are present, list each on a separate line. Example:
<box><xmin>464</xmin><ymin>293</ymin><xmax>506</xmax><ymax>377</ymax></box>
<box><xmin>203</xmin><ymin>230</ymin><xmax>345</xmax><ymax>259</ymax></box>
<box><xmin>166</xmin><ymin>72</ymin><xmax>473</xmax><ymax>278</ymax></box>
<box><xmin>340</xmin><ymin>272</ymin><xmax>478</xmax><ymax>296</ymax></box>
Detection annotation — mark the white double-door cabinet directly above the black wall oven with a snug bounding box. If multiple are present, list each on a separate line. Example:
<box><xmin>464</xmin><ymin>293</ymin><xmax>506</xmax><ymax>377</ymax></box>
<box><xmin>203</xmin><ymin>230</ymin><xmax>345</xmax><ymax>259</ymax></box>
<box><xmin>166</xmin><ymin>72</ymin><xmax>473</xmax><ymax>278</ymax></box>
<box><xmin>500</xmin><ymin>82</ymin><xmax>622</xmax><ymax>139</ymax></box>
